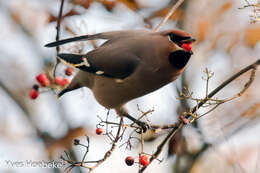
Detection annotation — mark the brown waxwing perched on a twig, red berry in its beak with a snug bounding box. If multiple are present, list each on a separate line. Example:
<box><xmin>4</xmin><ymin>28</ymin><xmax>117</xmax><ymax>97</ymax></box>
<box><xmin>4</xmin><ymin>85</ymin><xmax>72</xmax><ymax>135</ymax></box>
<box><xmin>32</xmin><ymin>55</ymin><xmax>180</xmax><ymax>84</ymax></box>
<box><xmin>45</xmin><ymin>29</ymin><xmax>196</xmax><ymax>131</ymax></box>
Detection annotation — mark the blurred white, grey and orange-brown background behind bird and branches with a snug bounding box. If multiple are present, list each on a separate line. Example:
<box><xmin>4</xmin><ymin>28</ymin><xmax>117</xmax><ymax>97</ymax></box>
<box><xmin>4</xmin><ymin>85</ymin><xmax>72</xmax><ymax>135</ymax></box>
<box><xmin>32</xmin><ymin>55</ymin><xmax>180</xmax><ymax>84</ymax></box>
<box><xmin>0</xmin><ymin>0</ymin><xmax>260</xmax><ymax>173</ymax></box>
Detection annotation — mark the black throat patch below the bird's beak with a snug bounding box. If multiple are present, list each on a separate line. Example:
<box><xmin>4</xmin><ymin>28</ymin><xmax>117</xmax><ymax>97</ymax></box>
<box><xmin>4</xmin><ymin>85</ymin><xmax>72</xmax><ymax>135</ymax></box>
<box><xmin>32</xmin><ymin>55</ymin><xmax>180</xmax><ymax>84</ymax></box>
<box><xmin>169</xmin><ymin>50</ymin><xmax>191</xmax><ymax>69</ymax></box>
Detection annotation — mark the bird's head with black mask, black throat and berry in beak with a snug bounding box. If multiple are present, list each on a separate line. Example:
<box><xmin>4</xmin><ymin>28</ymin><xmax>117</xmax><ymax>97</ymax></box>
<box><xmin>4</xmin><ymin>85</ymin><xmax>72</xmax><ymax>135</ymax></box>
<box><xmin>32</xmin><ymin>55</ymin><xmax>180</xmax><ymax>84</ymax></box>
<box><xmin>162</xmin><ymin>30</ymin><xmax>196</xmax><ymax>69</ymax></box>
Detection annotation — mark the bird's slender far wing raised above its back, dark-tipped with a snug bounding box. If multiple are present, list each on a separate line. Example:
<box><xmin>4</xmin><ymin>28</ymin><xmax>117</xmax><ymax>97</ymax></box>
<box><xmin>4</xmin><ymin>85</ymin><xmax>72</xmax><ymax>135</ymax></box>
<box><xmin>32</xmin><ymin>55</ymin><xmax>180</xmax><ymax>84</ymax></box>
<box><xmin>45</xmin><ymin>30</ymin><xmax>152</xmax><ymax>47</ymax></box>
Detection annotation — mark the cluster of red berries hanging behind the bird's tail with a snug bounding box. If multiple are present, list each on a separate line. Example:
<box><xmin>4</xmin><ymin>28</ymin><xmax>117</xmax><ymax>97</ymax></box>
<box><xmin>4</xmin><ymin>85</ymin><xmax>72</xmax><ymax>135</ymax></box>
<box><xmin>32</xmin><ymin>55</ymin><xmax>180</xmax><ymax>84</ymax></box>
<box><xmin>29</xmin><ymin>67</ymin><xmax>73</xmax><ymax>100</ymax></box>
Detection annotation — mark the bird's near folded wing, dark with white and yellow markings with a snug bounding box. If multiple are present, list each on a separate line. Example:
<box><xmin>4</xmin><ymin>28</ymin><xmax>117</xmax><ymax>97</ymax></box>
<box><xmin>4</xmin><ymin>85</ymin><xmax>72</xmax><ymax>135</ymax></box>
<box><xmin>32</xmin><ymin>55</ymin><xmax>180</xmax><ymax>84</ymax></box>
<box><xmin>58</xmin><ymin>52</ymin><xmax>140</xmax><ymax>79</ymax></box>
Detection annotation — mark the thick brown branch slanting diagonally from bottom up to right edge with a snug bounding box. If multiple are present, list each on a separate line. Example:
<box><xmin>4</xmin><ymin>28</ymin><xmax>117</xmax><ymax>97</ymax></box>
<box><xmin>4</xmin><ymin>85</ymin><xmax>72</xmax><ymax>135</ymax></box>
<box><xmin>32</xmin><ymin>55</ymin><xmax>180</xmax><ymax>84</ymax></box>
<box><xmin>139</xmin><ymin>59</ymin><xmax>260</xmax><ymax>173</ymax></box>
